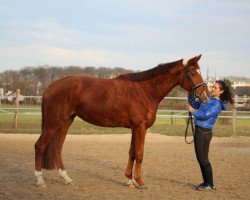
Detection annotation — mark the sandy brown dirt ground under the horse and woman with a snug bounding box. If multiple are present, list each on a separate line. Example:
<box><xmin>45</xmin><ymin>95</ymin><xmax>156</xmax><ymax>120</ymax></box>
<box><xmin>0</xmin><ymin>133</ymin><xmax>250</xmax><ymax>200</ymax></box>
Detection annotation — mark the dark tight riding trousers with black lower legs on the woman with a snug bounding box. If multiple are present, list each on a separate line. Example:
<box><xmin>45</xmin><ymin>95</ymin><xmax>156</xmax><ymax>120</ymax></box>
<box><xmin>194</xmin><ymin>126</ymin><xmax>213</xmax><ymax>186</ymax></box>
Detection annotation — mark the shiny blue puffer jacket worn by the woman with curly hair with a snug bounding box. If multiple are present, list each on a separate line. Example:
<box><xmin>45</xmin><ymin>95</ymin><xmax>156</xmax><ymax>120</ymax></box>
<box><xmin>188</xmin><ymin>97</ymin><xmax>227</xmax><ymax>129</ymax></box>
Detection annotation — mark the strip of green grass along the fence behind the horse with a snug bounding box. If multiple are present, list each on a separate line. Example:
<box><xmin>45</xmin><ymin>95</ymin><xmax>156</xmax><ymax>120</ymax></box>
<box><xmin>0</xmin><ymin>106</ymin><xmax>250</xmax><ymax>137</ymax></box>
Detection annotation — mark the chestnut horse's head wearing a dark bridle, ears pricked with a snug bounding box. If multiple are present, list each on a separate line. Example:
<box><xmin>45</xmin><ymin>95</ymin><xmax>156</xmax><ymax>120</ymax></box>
<box><xmin>179</xmin><ymin>55</ymin><xmax>208</xmax><ymax>102</ymax></box>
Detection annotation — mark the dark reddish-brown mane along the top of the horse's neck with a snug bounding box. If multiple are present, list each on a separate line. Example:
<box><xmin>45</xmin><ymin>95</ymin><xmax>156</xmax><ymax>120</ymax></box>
<box><xmin>117</xmin><ymin>61</ymin><xmax>178</xmax><ymax>81</ymax></box>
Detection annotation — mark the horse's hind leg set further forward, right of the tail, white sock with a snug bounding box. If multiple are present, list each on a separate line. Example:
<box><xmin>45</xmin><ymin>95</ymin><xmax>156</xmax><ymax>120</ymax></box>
<box><xmin>57</xmin><ymin>117</ymin><xmax>74</xmax><ymax>184</ymax></box>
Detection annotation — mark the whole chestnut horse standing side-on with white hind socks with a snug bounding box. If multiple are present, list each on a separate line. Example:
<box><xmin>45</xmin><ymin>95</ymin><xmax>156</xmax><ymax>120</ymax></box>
<box><xmin>35</xmin><ymin>55</ymin><xmax>208</xmax><ymax>188</ymax></box>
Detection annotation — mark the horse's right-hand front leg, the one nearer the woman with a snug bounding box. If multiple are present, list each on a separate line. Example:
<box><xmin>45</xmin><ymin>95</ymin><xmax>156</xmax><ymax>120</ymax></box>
<box><xmin>133</xmin><ymin>126</ymin><xmax>146</xmax><ymax>189</ymax></box>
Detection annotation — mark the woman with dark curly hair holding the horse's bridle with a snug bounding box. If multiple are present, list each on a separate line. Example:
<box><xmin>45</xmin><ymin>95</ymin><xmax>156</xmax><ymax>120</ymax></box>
<box><xmin>188</xmin><ymin>80</ymin><xmax>233</xmax><ymax>190</ymax></box>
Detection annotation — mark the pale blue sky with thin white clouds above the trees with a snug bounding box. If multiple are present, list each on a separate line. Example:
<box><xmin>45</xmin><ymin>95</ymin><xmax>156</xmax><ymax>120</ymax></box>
<box><xmin>0</xmin><ymin>0</ymin><xmax>250</xmax><ymax>77</ymax></box>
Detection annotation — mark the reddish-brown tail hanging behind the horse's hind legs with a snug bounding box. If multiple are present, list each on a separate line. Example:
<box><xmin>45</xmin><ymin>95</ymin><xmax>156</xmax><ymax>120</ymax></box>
<box><xmin>41</xmin><ymin>95</ymin><xmax>60</xmax><ymax>170</ymax></box>
